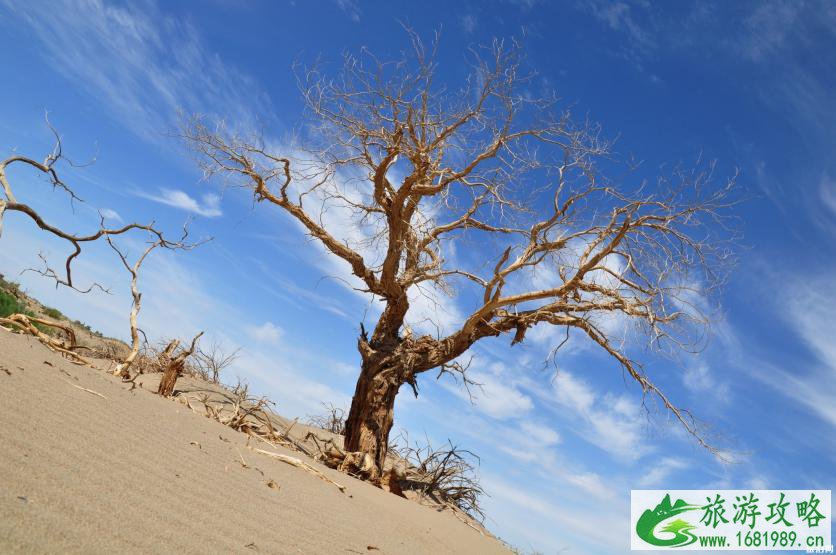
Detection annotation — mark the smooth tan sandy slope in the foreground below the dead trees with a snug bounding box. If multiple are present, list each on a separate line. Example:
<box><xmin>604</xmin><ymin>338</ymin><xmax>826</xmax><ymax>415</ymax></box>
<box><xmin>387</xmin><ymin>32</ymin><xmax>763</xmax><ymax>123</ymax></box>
<box><xmin>0</xmin><ymin>331</ymin><xmax>507</xmax><ymax>554</ymax></box>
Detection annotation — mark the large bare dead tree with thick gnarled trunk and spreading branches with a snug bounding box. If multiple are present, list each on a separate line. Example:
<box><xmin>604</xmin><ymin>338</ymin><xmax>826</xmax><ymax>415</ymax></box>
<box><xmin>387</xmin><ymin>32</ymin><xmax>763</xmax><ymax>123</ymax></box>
<box><xmin>184</xmin><ymin>36</ymin><xmax>735</xmax><ymax>478</ymax></box>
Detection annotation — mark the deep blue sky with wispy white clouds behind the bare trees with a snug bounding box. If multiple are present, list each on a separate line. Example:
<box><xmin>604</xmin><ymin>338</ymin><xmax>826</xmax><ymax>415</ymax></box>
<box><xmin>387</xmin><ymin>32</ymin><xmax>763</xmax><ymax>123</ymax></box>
<box><xmin>0</xmin><ymin>0</ymin><xmax>836</xmax><ymax>553</ymax></box>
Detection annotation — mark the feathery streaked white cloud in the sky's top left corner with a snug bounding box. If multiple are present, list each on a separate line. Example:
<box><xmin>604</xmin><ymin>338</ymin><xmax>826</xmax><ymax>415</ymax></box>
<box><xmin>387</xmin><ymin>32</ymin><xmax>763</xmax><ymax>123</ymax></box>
<box><xmin>0</xmin><ymin>0</ymin><xmax>272</xmax><ymax>141</ymax></box>
